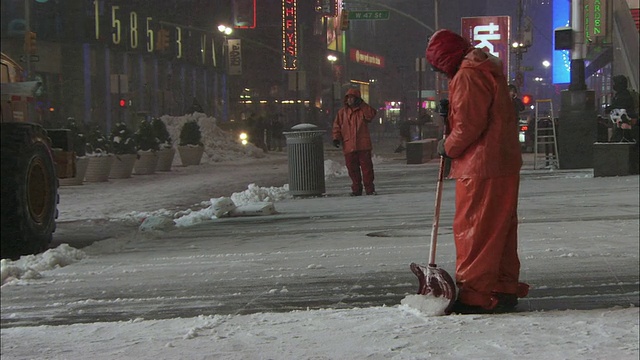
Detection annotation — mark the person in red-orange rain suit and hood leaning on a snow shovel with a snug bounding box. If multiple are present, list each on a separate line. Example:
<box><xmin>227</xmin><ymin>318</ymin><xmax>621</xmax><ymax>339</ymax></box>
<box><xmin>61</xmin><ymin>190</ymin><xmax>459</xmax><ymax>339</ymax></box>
<box><xmin>426</xmin><ymin>29</ymin><xmax>528</xmax><ymax>313</ymax></box>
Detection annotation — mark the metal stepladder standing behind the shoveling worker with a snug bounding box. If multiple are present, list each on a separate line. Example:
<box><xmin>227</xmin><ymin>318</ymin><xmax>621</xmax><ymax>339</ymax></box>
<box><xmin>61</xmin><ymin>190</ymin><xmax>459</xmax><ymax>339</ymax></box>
<box><xmin>533</xmin><ymin>99</ymin><xmax>560</xmax><ymax>169</ymax></box>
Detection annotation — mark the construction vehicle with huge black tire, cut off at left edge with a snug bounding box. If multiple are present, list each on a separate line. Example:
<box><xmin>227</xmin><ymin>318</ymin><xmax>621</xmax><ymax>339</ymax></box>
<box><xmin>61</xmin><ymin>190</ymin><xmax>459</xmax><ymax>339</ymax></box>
<box><xmin>0</xmin><ymin>54</ymin><xmax>73</xmax><ymax>259</ymax></box>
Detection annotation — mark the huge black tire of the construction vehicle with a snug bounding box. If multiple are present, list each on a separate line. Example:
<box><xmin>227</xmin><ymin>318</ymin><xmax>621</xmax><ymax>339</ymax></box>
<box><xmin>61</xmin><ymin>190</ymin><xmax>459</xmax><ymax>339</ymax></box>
<box><xmin>0</xmin><ymin>123</ymin><xmax>59</xmax><ymax>259</ymax></box>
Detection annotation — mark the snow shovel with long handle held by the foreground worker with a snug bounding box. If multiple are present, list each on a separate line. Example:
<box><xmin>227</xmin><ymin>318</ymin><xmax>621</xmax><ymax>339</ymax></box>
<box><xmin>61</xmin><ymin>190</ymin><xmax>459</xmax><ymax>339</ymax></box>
<box><xmin>410</xmin><ymin>107</ymin><xmax>456</xmax><ymax>313</ymax></box>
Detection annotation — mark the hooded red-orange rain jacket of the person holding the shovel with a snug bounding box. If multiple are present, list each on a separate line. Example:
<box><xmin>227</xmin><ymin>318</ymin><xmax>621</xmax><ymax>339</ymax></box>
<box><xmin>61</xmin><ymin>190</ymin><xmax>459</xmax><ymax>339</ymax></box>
<box><xmin>427</xmin><ymin>35</ymin><xmax>522</xmax><ymax>179</ymax></box>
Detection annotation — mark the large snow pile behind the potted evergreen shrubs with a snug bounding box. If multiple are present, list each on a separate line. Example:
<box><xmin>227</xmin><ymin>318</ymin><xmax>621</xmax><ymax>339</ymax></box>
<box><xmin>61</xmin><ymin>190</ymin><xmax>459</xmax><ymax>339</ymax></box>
<box><xmin>160</xmin><ymin>112</ymin><xmax>265</xmax><ymax>165</ymax></box>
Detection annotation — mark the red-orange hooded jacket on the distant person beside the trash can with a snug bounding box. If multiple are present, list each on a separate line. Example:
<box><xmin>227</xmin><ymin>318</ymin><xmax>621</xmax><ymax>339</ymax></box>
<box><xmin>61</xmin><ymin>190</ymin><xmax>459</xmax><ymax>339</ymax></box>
<box><xmin>332</xmin><ymin>89</ymin><xmax>376</xmax><ymax>154</ymax></box>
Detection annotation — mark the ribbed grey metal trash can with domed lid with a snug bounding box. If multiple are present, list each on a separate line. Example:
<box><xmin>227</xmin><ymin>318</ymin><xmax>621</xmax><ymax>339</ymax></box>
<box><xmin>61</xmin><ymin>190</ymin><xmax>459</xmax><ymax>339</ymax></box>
<box><xmin>283</xmin><ymin>124</ymin><xmax>325</xmax><ymax>196</ymax></box>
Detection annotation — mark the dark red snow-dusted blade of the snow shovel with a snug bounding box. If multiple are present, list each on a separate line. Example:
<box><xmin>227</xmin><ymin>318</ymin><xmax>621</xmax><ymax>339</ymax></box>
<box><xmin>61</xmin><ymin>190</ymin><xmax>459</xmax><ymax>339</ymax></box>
<box><xmin>410</xmin><ymin>263</ymin><xmax>456</xmax><ymax>308</ymax></box>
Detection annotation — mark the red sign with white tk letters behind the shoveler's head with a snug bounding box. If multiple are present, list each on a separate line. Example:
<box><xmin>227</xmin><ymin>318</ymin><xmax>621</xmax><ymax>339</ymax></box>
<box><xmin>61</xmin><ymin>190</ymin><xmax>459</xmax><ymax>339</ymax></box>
<box><xmin>462</xmin><ymin>16</ymin><xmax>511</xmax><ymax>75</ymax></box>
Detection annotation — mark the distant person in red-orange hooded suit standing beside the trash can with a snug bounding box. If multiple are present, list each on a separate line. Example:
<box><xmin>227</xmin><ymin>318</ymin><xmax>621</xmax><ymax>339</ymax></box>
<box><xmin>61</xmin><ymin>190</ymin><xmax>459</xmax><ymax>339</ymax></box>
<box><xmin>332</xmin><ymin>88</ymin><xmax>376</xmax><ymax>196</ymax></box>
